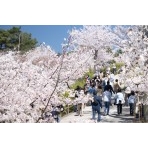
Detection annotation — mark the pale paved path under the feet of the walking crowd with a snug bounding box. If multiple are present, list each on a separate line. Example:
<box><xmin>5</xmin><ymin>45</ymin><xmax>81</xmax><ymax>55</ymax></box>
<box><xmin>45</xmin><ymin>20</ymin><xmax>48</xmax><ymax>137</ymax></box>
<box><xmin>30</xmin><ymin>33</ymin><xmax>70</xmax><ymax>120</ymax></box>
<box><xmin>61</xmin><ymin>106</ymin><xmax>134</xmax><ymax>123</ymax></box>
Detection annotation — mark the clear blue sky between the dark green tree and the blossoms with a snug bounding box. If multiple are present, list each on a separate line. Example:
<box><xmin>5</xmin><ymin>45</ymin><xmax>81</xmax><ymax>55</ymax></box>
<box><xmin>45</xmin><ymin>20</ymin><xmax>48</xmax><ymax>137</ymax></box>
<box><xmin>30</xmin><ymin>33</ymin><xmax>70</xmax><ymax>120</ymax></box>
<box><xmin>0</xmin><ymin>25</ymin><xmax>82</xmax><ymax>52</ymax></box>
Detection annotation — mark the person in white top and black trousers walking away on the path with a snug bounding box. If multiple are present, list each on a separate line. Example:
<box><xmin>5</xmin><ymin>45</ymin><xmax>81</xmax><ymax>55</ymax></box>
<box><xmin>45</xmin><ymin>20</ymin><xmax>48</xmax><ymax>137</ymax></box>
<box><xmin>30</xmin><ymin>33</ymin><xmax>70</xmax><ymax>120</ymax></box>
<box><xmin>115</xmin><ymin>88</ymin><xmax>125</xmax><ymax>115</ymax></box>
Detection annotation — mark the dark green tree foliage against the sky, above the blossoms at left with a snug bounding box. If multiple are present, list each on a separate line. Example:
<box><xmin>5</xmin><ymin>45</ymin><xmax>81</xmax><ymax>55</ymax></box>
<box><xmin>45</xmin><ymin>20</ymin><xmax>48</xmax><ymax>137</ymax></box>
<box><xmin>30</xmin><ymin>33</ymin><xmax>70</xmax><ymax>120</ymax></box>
<box><xmin>0</xmin><ymin>27</ymin><xmax>37</xmax><ymax>52</ymax></box>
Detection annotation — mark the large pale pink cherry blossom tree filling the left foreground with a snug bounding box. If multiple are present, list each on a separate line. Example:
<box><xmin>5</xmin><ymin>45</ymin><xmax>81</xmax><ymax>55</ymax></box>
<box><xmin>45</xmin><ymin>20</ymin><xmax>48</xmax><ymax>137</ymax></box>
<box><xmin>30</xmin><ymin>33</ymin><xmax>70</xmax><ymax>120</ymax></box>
<box><xmin>0</xmin><ymin>41</ymin><xmax>93</xmax><ymax>122</ymax></box>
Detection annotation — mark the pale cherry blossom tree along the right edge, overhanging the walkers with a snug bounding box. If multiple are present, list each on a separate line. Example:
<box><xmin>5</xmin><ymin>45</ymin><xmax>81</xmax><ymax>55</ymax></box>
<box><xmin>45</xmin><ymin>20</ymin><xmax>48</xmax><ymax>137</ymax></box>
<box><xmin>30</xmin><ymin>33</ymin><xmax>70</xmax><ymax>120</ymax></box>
<box><xmin>112</xmin><ymin>26</ymin><xmax>148</xmax><ymax>104</ymax></box>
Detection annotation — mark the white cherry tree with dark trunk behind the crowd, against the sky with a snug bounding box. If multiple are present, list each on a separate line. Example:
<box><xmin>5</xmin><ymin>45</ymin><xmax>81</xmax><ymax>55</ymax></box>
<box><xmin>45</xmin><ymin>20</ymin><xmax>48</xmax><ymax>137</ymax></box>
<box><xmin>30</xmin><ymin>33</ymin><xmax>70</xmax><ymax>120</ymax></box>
<box><xmin>69</xmin><ymin>25</ymin><xmax>121</xmax><ymax>71</ymax></box>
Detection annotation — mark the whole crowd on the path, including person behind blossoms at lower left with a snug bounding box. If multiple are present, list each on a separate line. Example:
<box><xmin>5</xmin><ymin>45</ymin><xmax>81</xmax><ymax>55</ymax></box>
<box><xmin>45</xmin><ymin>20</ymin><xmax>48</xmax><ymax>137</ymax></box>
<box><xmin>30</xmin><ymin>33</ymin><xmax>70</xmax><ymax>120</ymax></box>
<box><xmin>51</xmin><ymin>67</ymin><xmax>136</xmax><ymax>122</ymax></box>
